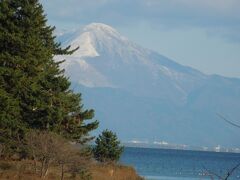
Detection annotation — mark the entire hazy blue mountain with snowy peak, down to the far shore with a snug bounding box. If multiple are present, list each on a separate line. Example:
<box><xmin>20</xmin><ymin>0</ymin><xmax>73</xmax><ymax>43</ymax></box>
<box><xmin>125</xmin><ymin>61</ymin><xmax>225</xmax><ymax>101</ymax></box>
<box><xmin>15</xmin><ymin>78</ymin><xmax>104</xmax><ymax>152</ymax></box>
<box><xmin>56</xmin><ymin>23</ymin><xmax>240</xmax><ymax>146</ymax></box>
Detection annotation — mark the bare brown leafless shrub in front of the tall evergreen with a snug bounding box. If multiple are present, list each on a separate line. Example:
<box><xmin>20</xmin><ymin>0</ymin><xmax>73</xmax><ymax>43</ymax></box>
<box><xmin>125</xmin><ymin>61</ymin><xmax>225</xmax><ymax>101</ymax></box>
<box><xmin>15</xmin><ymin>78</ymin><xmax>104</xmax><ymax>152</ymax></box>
<box><xmin>26</xmin><ymin>130</ymin><xmax>89</xmax><ymax>179</ymax></box>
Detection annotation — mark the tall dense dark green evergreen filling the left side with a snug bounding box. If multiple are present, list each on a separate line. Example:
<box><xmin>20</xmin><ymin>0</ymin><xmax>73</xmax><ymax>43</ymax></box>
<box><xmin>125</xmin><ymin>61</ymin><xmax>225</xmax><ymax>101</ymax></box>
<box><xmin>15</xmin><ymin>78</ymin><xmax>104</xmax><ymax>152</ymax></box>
<box><xmin>0</xmin><ymin>0</ymin><xmax>98</xmax><ymax>148</ymax></box>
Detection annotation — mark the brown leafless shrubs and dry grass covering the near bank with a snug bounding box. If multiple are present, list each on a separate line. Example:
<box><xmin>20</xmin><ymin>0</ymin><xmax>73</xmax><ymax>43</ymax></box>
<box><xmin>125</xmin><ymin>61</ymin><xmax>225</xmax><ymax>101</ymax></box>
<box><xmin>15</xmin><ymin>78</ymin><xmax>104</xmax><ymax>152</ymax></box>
<box><xmin>0</xmin><ymin>130</ymin><xmax>141</xmax><ymax>180</ymax></box>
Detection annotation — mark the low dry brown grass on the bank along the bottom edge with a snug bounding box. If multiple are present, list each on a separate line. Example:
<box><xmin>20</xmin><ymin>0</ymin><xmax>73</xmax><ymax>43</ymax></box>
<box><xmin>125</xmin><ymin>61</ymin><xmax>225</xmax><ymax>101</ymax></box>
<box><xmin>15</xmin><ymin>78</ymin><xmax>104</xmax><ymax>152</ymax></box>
<box><xmin>0</xmin><ymin>160</ymin><xmax>142</xmax><ymax>180</ymax></box>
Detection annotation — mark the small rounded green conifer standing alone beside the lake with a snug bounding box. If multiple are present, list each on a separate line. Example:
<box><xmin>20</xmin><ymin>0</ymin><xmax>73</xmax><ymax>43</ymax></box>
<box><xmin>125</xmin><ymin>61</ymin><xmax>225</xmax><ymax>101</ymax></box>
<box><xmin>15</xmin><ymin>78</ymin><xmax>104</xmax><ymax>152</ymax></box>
<box><xmin>93</xmin><ymin>130</ymin><xmax>124</xmax><ymax>162</ymax></box>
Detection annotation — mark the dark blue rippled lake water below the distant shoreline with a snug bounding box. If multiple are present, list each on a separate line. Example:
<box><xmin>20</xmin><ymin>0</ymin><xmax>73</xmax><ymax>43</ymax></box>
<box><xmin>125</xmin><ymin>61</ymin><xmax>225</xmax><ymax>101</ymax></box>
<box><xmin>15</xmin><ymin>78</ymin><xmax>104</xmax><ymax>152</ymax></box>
<box><xmin>120</xmin><ymin>147</ymin><xmax>240</xmax><ymax>180</ymax></box>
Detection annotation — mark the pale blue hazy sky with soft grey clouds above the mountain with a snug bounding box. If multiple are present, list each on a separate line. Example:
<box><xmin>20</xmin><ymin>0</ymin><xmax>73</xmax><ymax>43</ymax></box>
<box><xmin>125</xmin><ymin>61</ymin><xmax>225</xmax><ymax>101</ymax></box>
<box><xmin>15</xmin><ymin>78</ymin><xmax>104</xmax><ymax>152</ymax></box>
<box><xmin>40</xmin><ymin>0</ymin><xmax>240</xmax><ymax>78</ymax></box>
